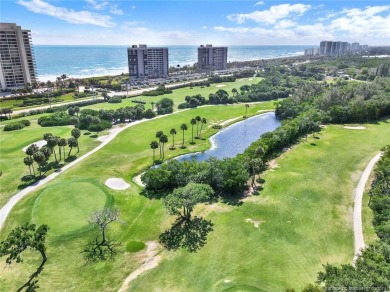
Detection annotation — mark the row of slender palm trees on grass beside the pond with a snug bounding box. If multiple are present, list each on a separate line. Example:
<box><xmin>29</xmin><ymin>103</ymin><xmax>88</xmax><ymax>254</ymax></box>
<box><xmin>150</xmin><ymin>116</ymin><xmax>207</xmax><ymax>162</ymax></box>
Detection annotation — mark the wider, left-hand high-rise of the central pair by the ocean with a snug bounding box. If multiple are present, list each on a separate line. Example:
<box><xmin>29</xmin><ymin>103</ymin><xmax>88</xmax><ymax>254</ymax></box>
<box><xmin>127</xmin><ymin>45</ymin><xmax>169</xmax><ymax>78</ymax></box>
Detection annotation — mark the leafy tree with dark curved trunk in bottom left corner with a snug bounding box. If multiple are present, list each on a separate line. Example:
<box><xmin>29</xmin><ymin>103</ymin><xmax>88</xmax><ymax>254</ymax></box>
<box><xmin>0</xmin><ymin>223</ymin><xmax>49</xmax><ymax>291</ymax></box>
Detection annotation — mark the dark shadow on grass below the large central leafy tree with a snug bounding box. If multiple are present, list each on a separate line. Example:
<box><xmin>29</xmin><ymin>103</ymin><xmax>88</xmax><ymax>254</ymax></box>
<box><xmin>160</xmin><ymin>217</ymin><xmax>214</xmax><ymax>252</ymax></box>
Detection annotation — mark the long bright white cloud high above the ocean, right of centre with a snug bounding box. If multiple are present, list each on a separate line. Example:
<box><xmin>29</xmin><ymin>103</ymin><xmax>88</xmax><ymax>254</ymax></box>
<box><xmin>227</xmin><ymin>4</ymin><xmax>311</xmax><ymax>24</ymax></box>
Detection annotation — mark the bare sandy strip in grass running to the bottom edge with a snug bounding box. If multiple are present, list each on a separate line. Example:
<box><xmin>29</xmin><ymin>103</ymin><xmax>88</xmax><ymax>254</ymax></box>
<box><xmin>119</xmin><ymin>241</ymin><xmax>161</xmax><ymax>292</ymax></box>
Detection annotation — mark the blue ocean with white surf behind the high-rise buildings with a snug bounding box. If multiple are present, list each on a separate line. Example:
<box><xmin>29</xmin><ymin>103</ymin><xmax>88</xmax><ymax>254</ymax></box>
<box><xmin>34</xmin><ymin>45</ymin><xmax>314</xmax><ymax>81</ymax></box>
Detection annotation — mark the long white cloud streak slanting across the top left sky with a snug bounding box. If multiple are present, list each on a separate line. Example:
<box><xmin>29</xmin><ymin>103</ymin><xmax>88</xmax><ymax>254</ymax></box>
<box><xmin>18</xmin><ymin>0</ymin><xmax>115</xmax><ymax>27</ymax></box>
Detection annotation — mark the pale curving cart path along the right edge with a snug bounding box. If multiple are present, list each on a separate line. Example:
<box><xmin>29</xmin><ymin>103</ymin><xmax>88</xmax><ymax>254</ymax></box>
<box><xmin>353</xmin><ymin>153</ymin><xmax>382</xmax><ymax>262</ymax></box>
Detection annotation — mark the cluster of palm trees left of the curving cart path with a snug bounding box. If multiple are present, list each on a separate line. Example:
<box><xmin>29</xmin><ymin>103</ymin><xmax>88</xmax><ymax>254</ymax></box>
<box><xmin>23</xmin><ymin>128</ymin><xmax>81</xmax><ymax>177</ymax></box>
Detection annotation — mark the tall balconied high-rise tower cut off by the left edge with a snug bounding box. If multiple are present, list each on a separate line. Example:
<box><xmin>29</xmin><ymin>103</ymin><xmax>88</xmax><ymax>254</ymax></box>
<box><xmin>0</xmin><ymin>23</ymin><xmax>36</xmax><ymax>90</ymax></box>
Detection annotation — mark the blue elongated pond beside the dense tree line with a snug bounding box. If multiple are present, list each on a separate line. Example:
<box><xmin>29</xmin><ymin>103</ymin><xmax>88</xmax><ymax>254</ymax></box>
<box><xmin>176</xmin><ymin>112</ymin><xmax>281</xmax><ymax>161</ymax></box>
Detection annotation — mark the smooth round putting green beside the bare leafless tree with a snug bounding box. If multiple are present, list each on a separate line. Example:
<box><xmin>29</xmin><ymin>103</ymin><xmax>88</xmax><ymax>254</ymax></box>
<box><xmin>32</xmin><ymin>181</ymin><xmax>106</xmax><ymax>235</ymax></box>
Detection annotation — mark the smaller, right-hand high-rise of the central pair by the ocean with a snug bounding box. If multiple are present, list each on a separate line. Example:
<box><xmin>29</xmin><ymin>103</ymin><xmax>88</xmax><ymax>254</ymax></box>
<box><xmin>198</xmin><ymin>45</ymin><xmax>227</xmax><ymax>70</ymax></box>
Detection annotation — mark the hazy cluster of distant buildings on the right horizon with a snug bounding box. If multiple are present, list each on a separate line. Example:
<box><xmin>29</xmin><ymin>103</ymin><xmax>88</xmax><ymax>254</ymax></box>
<box><xmin>305</xmin><ymin>41</ymin><xmax>368</xmax><ymax>56</ymax></box>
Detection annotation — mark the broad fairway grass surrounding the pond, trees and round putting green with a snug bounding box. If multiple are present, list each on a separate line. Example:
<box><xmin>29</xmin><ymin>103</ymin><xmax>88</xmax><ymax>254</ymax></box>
<box><xmin>0</xmin><ymin>108</ymin><xmax>390</xmax><ymax>291</ymax></box>
